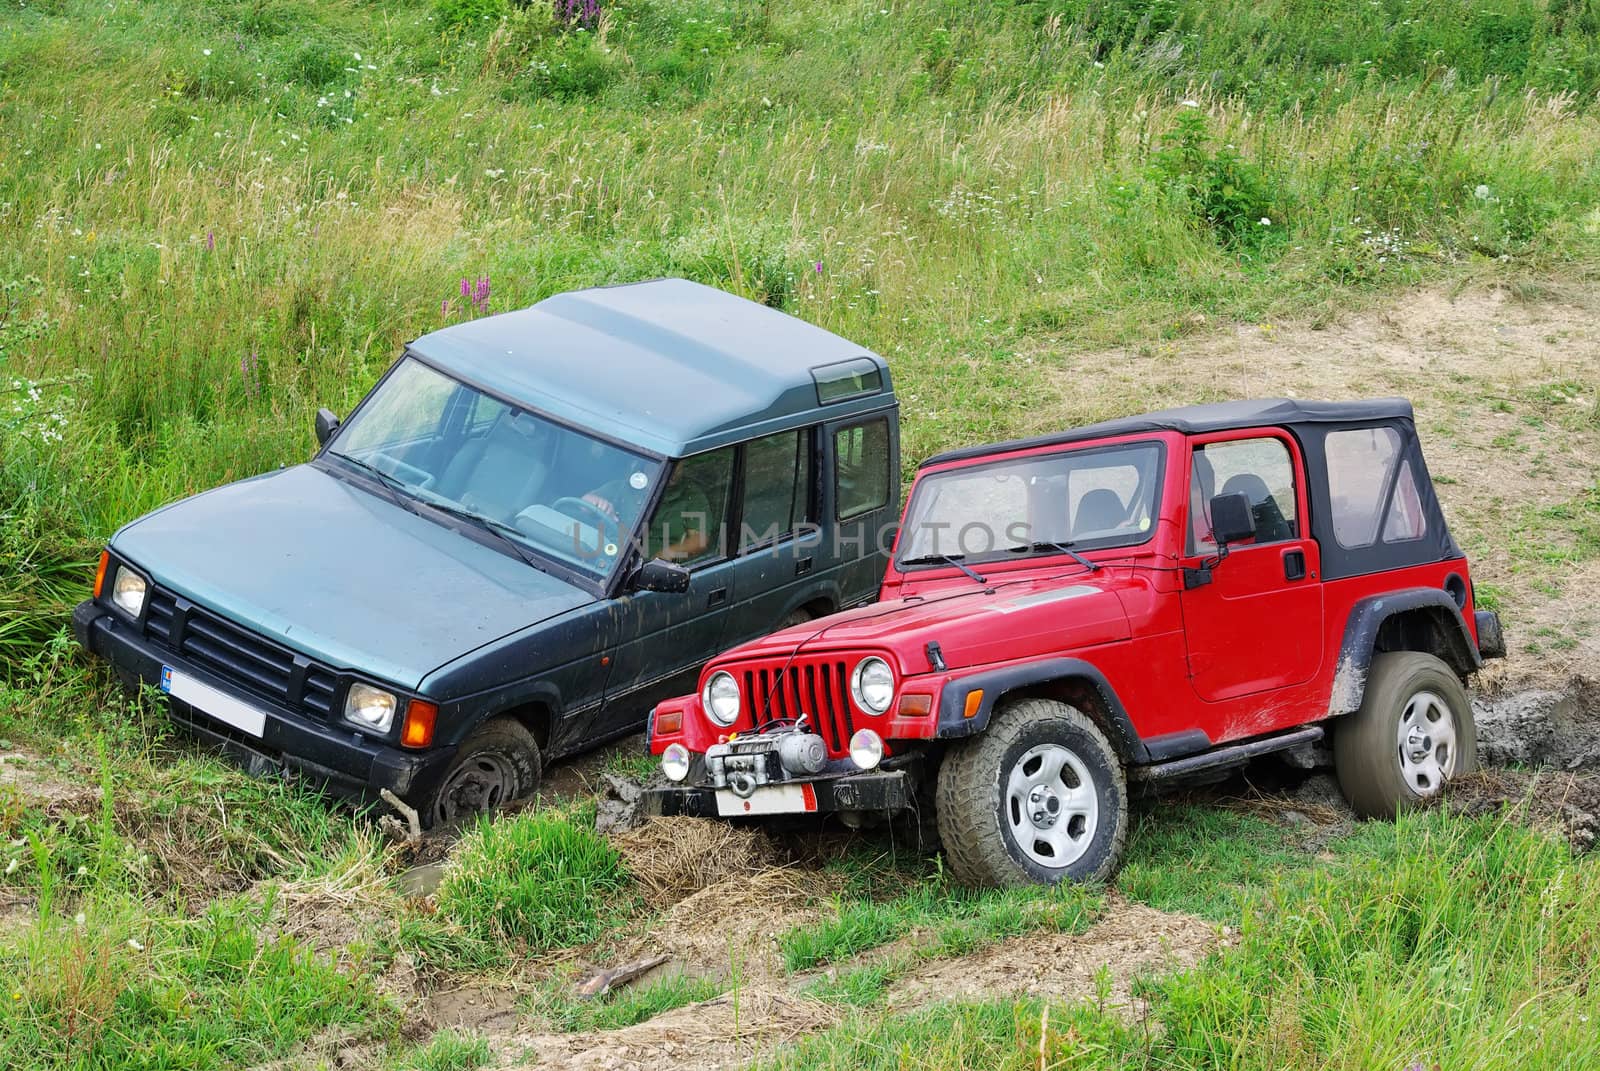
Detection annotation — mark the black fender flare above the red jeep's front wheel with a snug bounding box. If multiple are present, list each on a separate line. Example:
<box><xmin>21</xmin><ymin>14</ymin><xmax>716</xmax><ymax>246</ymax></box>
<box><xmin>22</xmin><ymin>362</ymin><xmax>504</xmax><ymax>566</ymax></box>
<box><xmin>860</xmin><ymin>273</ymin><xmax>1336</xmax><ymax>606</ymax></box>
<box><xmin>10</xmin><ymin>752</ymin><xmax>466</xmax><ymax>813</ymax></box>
<box><xmin>934</xmin><ymin>658</ymin><xmax>1150</xmax><ymax>762</ymax></box>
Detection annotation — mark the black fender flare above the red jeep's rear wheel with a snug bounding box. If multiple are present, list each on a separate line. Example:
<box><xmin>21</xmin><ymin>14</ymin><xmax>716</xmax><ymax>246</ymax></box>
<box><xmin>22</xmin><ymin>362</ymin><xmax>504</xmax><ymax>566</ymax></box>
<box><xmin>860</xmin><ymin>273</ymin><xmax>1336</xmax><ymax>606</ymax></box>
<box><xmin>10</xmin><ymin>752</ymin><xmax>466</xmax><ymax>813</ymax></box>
<box><xmin>1328</xmin><ymin>588</ymin><xmax>1483</xmax><ymax>717</ymax></box>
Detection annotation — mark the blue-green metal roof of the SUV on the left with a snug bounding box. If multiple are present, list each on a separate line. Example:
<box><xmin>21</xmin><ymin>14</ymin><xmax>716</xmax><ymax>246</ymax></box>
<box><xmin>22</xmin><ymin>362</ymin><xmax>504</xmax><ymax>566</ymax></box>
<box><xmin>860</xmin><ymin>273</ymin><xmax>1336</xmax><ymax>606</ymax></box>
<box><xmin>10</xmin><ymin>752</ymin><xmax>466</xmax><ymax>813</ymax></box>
<box><xmin>411</xmin><ymin>279</ymin><xmax>894</xmax><ymax>458</ymax></box>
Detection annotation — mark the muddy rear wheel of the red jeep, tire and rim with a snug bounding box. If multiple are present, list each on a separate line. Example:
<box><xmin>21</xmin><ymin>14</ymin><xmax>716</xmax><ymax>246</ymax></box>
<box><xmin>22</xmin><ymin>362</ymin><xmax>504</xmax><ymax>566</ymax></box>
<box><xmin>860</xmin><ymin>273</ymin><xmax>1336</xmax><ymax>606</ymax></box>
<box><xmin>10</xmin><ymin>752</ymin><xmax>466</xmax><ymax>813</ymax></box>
<box><xmin>1333</xmin><ymin>652</ymin><xmax>1478</xmax><ymax>818</ymax></box>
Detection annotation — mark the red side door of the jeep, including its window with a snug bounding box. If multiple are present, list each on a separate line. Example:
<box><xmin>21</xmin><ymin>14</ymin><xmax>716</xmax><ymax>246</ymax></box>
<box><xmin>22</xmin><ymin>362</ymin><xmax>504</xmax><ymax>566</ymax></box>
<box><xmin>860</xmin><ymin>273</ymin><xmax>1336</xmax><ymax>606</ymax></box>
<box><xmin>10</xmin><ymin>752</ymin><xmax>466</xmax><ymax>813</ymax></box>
<box><xmin>1182</xmin><ymin>429</ymin><xmax>1323</xmax><ymax>710</ymax></box>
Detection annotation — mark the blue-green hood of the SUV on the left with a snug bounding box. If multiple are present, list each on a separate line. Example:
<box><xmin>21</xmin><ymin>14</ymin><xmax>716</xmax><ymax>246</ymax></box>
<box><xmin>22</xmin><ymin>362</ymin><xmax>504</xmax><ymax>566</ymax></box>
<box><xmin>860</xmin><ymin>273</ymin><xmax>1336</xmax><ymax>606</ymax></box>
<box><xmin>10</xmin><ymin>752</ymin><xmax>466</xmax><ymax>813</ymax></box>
<box><xmin>112</xmin><ymin>464</ymin><xmax>595</xmax><ymax>688</ymax></box>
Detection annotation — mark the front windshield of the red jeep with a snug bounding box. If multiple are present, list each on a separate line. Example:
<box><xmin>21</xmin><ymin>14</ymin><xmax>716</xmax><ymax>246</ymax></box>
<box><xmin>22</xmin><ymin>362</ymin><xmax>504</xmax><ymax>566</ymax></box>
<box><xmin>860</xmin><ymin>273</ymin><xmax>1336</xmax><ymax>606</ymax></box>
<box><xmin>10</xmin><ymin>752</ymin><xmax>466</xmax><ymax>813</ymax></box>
<box><xmin>896</xmin><ymin>442</ymin><xmax>1163</xmax><ymax>565</ymax></box>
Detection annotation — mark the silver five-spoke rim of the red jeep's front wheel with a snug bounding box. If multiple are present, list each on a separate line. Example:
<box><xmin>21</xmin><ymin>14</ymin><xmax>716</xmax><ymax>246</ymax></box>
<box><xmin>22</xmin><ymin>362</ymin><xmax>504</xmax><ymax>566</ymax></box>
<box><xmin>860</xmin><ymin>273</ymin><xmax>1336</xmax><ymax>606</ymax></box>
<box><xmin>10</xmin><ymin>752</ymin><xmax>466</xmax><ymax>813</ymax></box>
<box><xmin>1005</xmin><ymin>744</ymin><xmax>1099</xmax><ymax>869</ymax></box>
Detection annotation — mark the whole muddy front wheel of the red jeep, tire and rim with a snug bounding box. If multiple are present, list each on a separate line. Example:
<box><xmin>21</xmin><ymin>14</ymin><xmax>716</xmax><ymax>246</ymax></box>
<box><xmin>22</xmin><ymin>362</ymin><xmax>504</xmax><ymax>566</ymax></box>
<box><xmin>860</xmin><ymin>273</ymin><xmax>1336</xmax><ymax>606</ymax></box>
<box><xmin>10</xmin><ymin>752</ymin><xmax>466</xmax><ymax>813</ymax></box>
<box><xmin>936</xmin><ymin>700</ymin><xmax>1128</xmax><ymax>885</ymax></box>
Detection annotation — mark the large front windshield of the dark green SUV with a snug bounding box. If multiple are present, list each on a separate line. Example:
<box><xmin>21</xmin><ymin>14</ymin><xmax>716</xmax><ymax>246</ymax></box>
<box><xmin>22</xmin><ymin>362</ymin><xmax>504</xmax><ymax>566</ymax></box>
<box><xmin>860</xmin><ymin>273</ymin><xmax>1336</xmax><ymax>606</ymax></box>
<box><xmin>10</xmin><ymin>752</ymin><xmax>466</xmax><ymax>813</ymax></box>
<box><xmin>328</xmin><ymin>357</ymin><xmax>661</xmax><ymax>576</ymax></box>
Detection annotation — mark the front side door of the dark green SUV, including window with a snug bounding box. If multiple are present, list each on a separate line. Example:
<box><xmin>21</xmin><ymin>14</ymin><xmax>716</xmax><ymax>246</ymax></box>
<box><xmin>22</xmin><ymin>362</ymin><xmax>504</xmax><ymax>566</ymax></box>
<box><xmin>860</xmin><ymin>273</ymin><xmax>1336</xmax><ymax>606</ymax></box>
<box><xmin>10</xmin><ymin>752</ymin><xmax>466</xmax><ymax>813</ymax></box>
<box><xmin>594</xmin><ymin>447</ymin><xmax>736</xmax><ymax>736</ymax></box>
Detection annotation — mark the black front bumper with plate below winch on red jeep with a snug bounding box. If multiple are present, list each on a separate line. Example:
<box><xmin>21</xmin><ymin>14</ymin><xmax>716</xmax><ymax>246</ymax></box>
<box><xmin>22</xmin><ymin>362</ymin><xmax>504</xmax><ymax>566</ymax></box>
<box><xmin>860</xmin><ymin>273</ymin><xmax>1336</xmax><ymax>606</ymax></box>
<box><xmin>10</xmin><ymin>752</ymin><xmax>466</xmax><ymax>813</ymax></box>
<box><xmin>642</xmin><ymin>770</ymin><xmax>912</xmax><ymax>818</ymax></box>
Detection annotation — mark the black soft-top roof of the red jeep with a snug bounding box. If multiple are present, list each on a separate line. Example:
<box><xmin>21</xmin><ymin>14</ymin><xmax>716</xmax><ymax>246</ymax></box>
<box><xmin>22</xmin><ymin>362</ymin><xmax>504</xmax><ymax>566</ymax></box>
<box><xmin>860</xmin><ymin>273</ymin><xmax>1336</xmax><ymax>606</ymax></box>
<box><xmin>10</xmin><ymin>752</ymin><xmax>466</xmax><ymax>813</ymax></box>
<box><xmin>923</xmin><ymin>399</ymin><xmax>1413</xmax><ymax>466</ymax></box>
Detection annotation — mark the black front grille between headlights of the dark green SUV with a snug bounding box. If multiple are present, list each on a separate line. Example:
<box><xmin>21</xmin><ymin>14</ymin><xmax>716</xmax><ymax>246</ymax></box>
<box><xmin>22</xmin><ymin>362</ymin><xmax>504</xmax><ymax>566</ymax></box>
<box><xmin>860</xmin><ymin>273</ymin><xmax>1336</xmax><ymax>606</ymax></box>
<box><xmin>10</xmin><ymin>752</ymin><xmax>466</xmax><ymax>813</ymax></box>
<box><xmin>144</xmin><ymin>588</ymin><xmax>339</xmax><ymax>720</ymax></box>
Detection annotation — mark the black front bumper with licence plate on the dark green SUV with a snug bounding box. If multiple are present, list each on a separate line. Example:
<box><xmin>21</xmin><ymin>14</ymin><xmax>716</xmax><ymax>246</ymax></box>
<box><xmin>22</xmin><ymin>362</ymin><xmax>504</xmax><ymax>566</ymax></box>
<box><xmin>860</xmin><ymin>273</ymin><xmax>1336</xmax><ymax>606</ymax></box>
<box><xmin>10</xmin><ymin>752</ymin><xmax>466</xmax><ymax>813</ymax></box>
<box><xmin>72</xmin><ymin>599</ymin><xmax>454</xmax><ymax>804</ymax></box>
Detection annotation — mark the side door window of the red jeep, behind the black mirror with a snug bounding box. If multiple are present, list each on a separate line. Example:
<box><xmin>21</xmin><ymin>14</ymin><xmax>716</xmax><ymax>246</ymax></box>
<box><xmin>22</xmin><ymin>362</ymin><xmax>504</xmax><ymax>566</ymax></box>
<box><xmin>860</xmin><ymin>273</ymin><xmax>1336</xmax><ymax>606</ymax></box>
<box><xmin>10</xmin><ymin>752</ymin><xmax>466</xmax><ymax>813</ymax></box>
<box><xmin>1189</xmin><ymin>435</ymin><xmax>1299</xmax><ymax>554</ymax></box>
